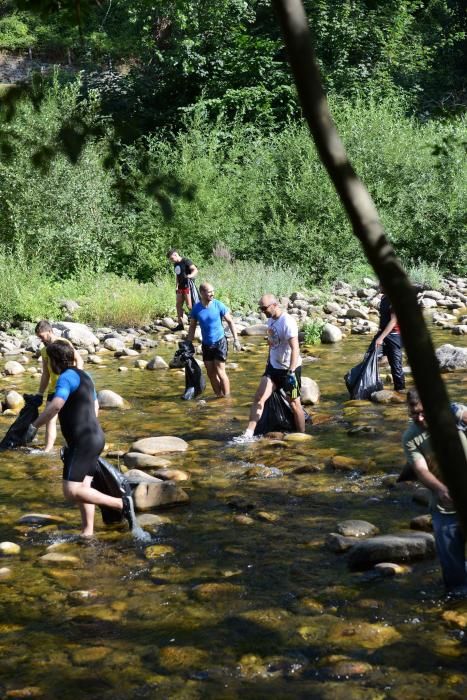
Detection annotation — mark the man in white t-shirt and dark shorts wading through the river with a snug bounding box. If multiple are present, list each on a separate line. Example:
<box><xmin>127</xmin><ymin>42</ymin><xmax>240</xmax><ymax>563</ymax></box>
<box><xmin>234</xmin><ymin>294</ymin><xmax>305</xmax><ymax>442</ymax></box>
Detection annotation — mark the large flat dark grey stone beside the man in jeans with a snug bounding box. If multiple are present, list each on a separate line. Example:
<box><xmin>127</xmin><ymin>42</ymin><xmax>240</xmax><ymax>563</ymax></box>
<box><xmin>348</xmin><ymin>532</ymin><xmax>435</xmax><ymax>571</ymax></box>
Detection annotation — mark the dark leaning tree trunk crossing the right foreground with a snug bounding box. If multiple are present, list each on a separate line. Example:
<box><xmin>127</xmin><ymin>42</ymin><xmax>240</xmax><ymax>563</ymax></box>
<box><xmin>272</xmin><ymin>0</ymin><xmax>467</xmax><ymax>532</ymax></box>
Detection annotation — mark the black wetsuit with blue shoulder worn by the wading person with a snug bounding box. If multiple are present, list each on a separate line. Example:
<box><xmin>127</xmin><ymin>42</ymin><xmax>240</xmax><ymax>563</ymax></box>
<box><xmin>55</xmin><ymin>367</ymin><xmax>105</xmax><ymax>481</ymax></box>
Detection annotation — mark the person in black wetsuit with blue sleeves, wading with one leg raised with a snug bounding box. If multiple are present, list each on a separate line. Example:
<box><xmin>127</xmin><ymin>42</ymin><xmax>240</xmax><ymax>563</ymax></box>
<box><xmin>26</xmin><ymin>340</ymin><xmax>131</xmax><ymax>537</ymax></box>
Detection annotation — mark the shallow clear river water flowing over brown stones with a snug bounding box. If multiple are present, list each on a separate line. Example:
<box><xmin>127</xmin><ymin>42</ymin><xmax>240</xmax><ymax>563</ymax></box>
<box><xmin>0</xmin><ymin>331</ymin><xmax>467</xmax><ymax>700</ymax></box>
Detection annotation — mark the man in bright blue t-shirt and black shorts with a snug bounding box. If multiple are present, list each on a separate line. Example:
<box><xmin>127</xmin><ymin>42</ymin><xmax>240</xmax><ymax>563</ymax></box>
<box><xmin>187</xmin><ymin>282</ymin><xmax>242</xmax><ymax>398</ymax></box>
